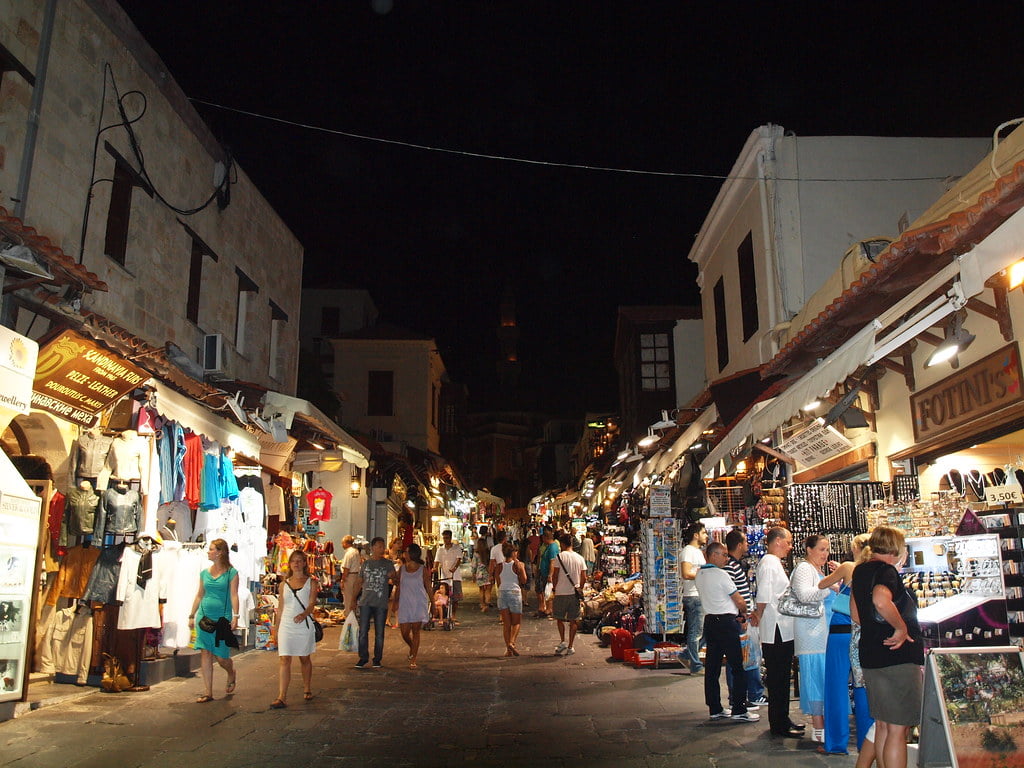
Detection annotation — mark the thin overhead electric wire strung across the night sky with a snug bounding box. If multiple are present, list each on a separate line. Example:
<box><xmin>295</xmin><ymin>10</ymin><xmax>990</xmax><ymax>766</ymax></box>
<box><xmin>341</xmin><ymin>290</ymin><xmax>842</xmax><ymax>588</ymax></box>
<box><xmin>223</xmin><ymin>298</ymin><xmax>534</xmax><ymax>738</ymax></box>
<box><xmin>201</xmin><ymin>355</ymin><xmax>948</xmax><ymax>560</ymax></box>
<box><xmin>188</xmin><ymin>97</ymin><xmax>949</xmax><ymax>182</ymax></box>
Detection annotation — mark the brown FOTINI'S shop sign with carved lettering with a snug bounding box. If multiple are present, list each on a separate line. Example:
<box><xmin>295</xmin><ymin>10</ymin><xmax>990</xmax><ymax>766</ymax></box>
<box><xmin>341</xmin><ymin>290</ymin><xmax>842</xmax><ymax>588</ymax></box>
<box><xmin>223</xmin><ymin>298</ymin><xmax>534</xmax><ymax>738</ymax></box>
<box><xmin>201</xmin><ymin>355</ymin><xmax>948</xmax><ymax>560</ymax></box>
<box><xmin>910</xmin><ymin>342</ymin><xmax>1024</xmax><ymax>442</ymax></box>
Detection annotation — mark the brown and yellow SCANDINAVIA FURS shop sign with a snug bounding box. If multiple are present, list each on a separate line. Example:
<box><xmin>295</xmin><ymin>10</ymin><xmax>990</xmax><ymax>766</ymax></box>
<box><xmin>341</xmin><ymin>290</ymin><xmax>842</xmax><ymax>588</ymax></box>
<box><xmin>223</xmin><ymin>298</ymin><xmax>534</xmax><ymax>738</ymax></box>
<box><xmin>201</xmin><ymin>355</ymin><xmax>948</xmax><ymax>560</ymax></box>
<box><xmin>32</xmin><ymin>331</ymin><xmax>148</xmax><ymax>427</ymax></box>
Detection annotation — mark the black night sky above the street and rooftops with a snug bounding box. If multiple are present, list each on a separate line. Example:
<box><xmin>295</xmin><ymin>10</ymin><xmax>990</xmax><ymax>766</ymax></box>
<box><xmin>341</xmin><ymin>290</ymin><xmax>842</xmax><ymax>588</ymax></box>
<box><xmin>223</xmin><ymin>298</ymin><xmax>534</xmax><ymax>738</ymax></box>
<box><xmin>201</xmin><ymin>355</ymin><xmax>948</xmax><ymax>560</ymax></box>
<box><xmin>116</xmin><ymin>0</ymin><xmax>1024</xmax><ymax>414</ymax></box>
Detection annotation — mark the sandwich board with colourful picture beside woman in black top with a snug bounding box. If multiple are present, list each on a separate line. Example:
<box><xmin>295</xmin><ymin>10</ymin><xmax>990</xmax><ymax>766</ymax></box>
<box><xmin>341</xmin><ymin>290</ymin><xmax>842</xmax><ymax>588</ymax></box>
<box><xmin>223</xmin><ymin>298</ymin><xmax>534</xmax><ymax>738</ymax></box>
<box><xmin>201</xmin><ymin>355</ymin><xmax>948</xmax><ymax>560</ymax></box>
<box><xmin>918</xmin><ymin>646</ymin><xmax>1024</xmax><ymax>768</ymax></box>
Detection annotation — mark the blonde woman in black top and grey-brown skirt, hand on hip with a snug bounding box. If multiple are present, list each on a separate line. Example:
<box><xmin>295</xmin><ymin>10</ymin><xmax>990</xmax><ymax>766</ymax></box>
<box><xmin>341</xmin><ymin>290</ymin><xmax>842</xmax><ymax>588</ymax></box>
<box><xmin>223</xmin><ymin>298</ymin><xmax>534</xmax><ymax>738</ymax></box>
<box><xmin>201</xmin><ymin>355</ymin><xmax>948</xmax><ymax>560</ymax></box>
<box><xmin>850</xmin><ymin>525</ymin><xmax>925</xmax><ymax>768</ymax></box>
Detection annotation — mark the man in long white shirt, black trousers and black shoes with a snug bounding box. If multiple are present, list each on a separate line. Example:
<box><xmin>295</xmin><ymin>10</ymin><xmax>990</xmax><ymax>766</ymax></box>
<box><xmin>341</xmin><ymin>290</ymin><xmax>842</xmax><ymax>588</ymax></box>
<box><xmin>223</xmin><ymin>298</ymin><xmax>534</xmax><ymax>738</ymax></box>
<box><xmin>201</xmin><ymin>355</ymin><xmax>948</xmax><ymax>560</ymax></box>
<box><xmin>751</xmin><ymin>527</ymin><xmax>804</xmax><ymax>738</ymax></box>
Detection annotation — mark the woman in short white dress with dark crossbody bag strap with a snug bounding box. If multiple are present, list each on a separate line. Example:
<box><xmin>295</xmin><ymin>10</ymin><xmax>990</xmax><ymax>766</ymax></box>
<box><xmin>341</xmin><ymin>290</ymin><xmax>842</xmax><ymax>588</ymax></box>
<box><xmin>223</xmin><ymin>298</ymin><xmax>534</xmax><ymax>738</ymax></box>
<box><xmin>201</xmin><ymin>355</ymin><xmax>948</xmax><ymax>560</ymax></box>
<box><xmin>270</xmin><ymin>550</ymin><xmax>319</xmax><ymax>710</ymax></box>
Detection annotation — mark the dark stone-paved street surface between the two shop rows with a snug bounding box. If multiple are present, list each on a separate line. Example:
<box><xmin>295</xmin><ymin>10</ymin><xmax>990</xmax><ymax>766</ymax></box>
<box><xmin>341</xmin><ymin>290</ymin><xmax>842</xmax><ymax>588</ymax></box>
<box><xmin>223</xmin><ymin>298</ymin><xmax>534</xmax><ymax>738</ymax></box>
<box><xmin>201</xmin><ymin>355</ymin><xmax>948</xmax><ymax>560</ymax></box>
<box><xmin>0</xmin><ymin>590</ymin><xmax>855</xmax><ymax>768</ymax></box>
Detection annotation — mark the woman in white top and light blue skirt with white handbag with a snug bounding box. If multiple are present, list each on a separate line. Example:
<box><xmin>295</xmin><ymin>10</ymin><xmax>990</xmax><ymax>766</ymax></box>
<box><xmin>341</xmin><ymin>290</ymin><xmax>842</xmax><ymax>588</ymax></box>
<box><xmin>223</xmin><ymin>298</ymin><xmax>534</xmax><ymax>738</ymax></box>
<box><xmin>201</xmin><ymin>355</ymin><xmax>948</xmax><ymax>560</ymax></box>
<box><xmin>790</xmin><ymin>536</ymin><xmax>836</xmax><ymax>743</ymax></box>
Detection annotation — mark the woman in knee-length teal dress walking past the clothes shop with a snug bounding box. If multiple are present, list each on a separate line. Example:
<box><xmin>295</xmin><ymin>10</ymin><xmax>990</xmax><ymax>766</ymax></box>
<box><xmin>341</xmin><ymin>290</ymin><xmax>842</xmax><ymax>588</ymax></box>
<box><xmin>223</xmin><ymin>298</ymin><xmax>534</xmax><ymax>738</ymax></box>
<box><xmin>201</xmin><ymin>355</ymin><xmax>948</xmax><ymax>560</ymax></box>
<box><xmin>188</xmin><ymin>539</ymin><xmax>239</xmax><ymax>703</ymax></box>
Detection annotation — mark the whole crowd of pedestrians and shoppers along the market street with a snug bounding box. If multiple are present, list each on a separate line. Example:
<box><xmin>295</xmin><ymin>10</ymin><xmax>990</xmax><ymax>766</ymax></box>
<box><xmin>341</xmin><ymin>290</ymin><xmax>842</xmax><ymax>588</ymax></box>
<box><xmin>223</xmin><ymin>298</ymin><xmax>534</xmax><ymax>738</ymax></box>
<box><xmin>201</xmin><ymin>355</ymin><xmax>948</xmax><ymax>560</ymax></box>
<box><xmin>189</xmin><ymin>523</ymin><xmax>924</xmax><ymax>768</ymax></box>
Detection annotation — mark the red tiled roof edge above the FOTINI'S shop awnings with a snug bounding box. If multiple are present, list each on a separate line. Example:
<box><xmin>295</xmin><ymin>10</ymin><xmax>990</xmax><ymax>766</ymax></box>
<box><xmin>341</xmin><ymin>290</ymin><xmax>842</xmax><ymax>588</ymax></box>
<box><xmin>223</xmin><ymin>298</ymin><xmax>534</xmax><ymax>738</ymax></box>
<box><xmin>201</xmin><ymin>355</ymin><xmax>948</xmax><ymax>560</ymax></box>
<box><xmin>762</xmin><ymin>161</ymin><xmax>1024</xmax><ymax>376</ymax></box>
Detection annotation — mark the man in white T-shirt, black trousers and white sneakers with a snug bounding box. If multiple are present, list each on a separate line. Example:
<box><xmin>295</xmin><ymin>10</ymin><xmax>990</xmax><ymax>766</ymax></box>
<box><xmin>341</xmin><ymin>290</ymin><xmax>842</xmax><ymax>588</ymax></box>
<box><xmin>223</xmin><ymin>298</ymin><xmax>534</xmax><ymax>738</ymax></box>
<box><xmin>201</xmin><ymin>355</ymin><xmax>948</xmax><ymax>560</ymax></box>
<box><xmin>693</xmin><ymin>542</ymin><xmax>761</xmax><ymax>723</ymax></box>
